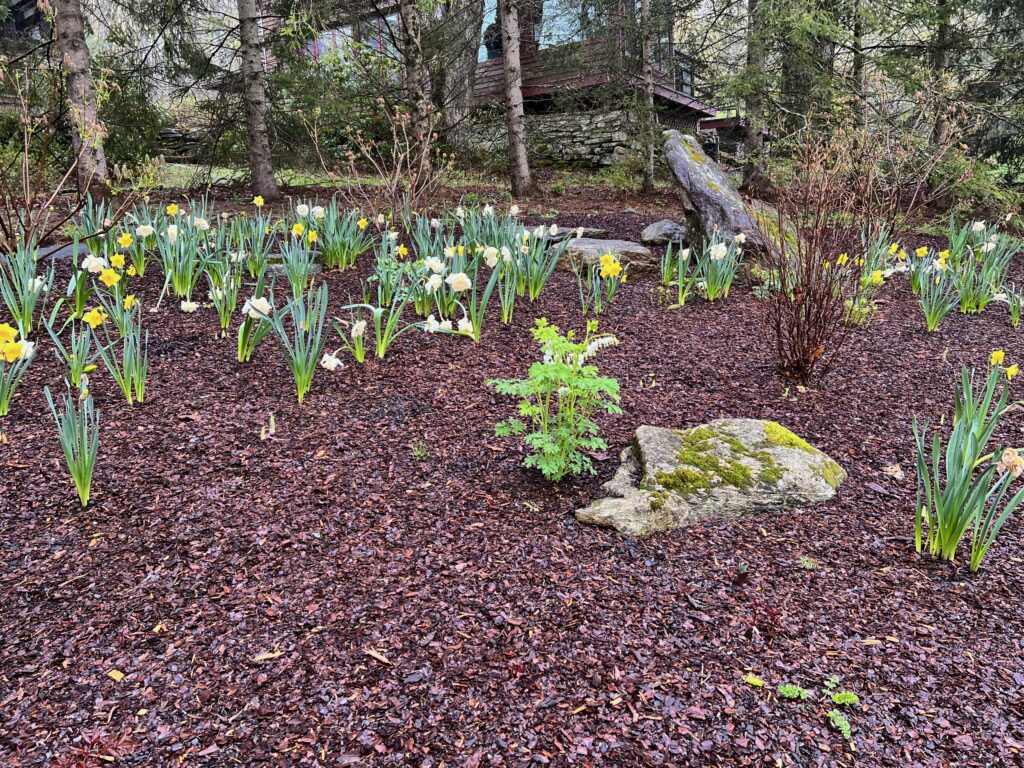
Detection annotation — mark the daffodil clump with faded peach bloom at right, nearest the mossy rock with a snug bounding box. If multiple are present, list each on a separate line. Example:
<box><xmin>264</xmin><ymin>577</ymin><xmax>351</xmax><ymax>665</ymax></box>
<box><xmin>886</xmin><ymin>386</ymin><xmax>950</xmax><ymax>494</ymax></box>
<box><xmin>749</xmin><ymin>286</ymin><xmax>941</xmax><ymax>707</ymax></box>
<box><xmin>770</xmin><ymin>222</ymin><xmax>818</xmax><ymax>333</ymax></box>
<box><xmin>913</xmin><ymin>360</ymin><xmax>1024</xmax><ymax>571</ymax></box>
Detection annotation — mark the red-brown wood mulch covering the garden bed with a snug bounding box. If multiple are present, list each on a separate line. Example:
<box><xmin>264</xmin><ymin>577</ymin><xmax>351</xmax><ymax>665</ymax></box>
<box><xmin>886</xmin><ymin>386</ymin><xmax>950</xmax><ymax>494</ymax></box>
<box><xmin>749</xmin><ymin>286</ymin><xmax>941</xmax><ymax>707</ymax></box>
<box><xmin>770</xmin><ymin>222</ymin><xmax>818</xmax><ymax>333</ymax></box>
<box><xmin>0</xmin><ymin>210</ymin><xmax>1024</xmax><ymax>768</ymax></box>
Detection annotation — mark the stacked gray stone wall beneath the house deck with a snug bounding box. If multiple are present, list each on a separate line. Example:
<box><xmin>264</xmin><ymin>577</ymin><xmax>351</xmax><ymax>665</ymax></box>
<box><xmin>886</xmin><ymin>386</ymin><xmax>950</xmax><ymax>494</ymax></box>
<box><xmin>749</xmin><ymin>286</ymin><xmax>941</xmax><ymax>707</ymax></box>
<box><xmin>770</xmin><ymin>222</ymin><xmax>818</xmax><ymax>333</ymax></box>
<box><xmin>468</xmin><ymin>111</ymin><xmax>642</xmax><ymax>168</ymax></box>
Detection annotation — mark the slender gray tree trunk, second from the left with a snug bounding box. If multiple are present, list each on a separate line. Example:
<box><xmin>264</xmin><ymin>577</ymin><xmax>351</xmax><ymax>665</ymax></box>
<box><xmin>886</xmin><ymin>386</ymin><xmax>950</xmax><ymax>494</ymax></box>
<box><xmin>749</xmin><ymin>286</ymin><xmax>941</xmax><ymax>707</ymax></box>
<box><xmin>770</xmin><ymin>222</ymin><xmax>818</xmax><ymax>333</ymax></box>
<box><xmin>239</xmin><ymin>0</ymin><xmax>281</xmax><ymax>200</ymax></box>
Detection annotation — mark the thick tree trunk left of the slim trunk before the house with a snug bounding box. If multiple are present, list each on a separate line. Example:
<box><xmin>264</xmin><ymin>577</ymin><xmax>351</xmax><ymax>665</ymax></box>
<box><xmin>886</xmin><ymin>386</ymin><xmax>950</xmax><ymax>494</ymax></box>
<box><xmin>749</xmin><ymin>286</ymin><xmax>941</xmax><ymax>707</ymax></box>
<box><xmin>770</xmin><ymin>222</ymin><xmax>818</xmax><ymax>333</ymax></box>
<box><xmin>428</xmin><ymin>0</ymin><xmax>483</xmax><ymax>146</ymax></box>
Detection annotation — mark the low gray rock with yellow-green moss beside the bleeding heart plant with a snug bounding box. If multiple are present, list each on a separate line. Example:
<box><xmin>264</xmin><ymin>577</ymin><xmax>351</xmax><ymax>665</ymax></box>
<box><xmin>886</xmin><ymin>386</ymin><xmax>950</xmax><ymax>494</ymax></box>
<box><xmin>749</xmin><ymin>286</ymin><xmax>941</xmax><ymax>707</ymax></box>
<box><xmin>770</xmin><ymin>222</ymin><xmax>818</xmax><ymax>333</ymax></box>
<box><xmin>575</xmin><ymin>419</ymin><xmax>846</xmax><ymax>537</ymax></box>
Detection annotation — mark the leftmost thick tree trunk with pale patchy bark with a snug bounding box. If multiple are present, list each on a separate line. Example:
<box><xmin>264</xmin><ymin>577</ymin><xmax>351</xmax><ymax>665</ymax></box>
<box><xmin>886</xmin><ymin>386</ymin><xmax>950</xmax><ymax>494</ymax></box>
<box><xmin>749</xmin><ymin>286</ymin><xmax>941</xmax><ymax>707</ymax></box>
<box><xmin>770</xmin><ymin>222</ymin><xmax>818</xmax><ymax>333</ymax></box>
<box><xmin>53</xmin><ymin>0</ymin><xmax>109</xmax><ymax>198</ymax></box>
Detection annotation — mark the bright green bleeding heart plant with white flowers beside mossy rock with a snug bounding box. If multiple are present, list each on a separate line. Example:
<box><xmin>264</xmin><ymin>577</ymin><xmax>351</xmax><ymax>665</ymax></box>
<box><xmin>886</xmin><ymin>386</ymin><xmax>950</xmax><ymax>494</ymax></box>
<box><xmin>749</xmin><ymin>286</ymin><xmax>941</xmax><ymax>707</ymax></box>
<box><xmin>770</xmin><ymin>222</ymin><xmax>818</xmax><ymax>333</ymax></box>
<box><xmin>487</xmin><ymin>317</ymin><xmax>622</xmax><ymax>482</ymax></box>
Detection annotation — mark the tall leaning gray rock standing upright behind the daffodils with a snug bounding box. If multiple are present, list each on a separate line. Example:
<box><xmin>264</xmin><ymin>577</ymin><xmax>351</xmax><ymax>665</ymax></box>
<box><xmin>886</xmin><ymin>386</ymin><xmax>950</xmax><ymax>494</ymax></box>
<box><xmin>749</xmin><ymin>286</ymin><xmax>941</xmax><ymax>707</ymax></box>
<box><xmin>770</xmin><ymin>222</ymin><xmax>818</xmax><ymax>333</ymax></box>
<box><xmin>665</xmin><ymin>130</ymin><xmax>763</xmax><ymax>247</ymax></box>
